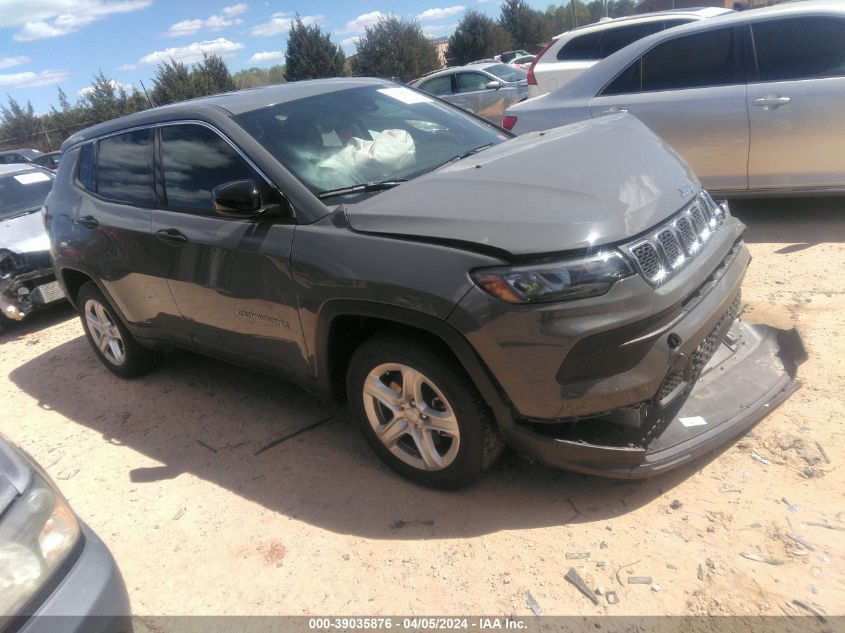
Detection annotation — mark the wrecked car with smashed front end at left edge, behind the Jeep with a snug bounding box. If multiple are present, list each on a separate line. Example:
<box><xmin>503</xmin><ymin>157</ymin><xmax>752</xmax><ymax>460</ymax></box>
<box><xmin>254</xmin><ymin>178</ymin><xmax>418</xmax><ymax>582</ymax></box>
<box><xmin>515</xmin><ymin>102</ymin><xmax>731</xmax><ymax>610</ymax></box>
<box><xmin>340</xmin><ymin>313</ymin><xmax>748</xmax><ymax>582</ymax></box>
<box><xmin>0</xmin><ymin>164</ymin><xmax>64</xmax><ymax>331</ymax></box>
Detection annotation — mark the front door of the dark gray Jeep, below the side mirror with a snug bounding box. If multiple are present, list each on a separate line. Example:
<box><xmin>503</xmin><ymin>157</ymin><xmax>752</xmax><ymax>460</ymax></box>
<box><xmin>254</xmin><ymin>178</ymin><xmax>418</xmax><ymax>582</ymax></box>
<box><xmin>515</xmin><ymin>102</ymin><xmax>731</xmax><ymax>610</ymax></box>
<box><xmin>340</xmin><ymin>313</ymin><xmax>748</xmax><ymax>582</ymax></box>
<box><xmin>153</xmin><ymin>123</ymin><xmax>307</xmax><ymax>374</ymax></box>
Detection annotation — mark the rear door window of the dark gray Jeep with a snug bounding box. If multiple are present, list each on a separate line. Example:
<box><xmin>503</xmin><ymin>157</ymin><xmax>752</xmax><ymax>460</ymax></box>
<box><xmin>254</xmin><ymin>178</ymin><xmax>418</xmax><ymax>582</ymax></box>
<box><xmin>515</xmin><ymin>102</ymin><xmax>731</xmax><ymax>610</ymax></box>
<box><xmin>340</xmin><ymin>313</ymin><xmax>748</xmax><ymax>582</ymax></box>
<box><xmin>97</xmin><ymin>129</ymin><xmax>155</xmax><ymax>207</ymax></box>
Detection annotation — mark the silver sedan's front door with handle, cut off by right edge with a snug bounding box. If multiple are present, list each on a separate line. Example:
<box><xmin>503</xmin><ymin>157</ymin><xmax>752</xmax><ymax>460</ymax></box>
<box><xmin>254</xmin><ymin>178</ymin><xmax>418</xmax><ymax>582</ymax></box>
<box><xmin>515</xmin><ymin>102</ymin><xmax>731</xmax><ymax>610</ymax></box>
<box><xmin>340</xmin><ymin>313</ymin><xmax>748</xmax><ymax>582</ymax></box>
<box><xmin>748</xmin><ymin>16</ymin><xmax>845</xmax><ymax>189</ymax></box>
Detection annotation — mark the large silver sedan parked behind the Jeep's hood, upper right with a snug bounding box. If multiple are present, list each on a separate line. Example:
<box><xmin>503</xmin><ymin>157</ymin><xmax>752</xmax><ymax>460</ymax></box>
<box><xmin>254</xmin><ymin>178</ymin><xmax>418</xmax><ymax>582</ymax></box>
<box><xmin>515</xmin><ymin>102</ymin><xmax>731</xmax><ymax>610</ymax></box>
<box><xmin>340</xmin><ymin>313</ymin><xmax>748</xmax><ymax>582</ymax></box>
<box><xmin>503</xmin><ymin>2</ymin><xmax>845</xmax><ymax>195</ymax></box>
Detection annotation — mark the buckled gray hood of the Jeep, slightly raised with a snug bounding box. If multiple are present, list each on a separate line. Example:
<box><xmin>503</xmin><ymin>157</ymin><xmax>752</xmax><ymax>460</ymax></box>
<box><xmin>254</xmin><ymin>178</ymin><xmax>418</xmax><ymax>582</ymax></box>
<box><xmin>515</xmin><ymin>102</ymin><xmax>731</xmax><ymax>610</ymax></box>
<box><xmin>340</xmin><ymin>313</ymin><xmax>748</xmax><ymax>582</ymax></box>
<box><xmin>346</xmin><ymin>113</ymin><xmax>700</xmax><ymax>255</ymax></box>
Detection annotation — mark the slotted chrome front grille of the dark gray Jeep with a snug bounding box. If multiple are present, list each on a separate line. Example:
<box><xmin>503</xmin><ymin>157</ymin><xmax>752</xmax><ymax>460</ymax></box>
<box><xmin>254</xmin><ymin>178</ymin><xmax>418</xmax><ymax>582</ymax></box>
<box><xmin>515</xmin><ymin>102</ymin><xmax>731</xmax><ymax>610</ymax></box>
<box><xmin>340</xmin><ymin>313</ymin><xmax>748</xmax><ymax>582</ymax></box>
<box><xmin>622</xmin><ymin>190</ymin><xmax>726</xmax><ymax>286</ymax></box>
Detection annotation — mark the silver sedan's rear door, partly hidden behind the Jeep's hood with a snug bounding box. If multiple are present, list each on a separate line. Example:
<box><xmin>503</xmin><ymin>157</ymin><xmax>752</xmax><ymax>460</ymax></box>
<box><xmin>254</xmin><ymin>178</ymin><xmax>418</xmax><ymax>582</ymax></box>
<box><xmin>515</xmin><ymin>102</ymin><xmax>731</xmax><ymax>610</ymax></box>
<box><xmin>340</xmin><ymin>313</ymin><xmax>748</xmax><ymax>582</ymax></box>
<box><xmin>590</xmin><ymin>27</ymin><xmax>749</xmax><ymax>191</ymax></box>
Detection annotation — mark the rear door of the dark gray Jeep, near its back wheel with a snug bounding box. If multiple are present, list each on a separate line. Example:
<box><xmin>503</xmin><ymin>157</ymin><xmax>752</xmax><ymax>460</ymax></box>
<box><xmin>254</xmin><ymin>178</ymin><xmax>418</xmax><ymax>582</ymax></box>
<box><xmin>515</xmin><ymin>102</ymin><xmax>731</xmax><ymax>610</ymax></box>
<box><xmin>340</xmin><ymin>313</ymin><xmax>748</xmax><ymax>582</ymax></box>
<box><xmin>62</xmin><ymin>128</ymin><xmax>183</xmax><ymax>342</ymax></box>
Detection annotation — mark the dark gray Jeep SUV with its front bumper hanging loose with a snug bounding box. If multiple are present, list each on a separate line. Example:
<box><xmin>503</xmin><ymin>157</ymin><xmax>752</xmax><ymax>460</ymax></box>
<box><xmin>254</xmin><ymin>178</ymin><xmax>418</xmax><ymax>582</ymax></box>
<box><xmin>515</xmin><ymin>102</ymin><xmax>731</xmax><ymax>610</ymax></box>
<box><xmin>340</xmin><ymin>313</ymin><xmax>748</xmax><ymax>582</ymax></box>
<box><xmin>45</xmin><ymin>78</ymin><xmax>803</xmax><ymax>487</ymax></box>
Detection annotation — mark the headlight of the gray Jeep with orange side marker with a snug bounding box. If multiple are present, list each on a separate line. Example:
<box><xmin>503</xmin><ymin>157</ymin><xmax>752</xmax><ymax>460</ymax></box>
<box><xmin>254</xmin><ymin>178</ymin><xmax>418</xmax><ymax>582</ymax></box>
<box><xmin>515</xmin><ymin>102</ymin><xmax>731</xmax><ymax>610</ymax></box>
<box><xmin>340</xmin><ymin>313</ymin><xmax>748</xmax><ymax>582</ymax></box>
<box><xmin>472</xmin><ymin>251</ymin><xmax>634</xmax><ymax>303</ymax></box>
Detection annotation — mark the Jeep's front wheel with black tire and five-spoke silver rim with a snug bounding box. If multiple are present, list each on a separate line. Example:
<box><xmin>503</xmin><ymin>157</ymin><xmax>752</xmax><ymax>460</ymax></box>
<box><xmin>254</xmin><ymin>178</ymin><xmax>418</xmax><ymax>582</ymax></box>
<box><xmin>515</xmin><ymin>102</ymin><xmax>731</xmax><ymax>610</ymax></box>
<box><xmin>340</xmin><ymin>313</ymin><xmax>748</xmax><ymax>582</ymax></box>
<box><xmin>347</xmin><ymin>335</ymin><xmax>504</xmax><ymax>488</ymax></box>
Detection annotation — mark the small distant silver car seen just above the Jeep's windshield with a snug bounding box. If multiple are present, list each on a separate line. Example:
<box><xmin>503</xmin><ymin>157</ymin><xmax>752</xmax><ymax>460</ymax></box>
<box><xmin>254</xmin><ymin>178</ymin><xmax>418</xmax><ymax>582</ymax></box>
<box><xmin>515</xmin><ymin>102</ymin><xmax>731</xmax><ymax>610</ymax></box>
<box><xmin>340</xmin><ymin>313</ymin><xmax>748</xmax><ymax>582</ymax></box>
<box><xmin>411</xmin><ymin>62</ymin><xmax>528</xmax><ymax>124</ymax></box>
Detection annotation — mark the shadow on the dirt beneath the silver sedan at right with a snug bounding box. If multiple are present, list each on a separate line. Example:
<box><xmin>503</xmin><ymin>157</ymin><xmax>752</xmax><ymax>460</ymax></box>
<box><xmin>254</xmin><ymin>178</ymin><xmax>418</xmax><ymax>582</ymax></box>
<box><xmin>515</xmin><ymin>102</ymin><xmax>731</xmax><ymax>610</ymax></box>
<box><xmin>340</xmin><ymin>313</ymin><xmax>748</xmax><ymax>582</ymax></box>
<box><xmin>731</xmin><ymin>196</ymin><xmax>845</xmax><ymax>244</ymax></box>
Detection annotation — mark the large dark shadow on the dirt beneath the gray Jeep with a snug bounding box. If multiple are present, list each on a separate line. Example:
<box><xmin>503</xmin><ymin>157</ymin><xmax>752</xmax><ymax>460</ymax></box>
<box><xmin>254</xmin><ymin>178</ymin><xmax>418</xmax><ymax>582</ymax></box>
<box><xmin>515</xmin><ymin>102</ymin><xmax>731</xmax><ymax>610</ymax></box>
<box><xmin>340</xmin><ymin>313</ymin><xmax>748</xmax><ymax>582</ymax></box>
<box><xmin>10</xmin><ymin>337</ymin><xmax>724</xmax><ymax>539</ymax></box>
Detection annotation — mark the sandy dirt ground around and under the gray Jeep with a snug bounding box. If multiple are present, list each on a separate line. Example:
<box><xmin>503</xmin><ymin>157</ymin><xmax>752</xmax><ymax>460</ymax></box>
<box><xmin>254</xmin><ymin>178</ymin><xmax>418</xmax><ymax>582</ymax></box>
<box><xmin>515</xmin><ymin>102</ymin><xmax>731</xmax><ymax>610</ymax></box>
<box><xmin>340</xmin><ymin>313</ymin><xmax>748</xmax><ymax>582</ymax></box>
<box><xmin>0</xmin><ymin>199</ymin><xmax>845</xmax><ymax>615</ymax></box>
